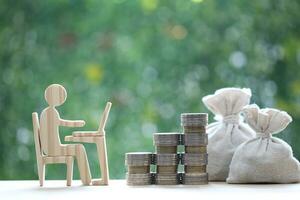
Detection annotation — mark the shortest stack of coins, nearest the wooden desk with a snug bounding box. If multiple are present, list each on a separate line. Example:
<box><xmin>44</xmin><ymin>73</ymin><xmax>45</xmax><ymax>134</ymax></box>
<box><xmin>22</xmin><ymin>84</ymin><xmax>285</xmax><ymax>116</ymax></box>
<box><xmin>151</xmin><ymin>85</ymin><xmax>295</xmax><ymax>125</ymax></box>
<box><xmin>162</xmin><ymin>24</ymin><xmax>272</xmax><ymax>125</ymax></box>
<box><xmin>125</xmin><ymin>152</ymin><xmax>154</xmax><ymax>185</ymax></box>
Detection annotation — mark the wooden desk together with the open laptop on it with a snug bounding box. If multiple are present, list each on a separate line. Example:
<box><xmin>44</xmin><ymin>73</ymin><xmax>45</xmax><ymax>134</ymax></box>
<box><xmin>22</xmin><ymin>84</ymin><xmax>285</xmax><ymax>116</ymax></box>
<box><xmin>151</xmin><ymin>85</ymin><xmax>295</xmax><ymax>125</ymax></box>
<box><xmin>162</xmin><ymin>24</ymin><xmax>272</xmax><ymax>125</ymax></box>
<box><xmin>65</xmin><ymin>102</ymin><xmax>112</xmax><ymax>185</ymax></box>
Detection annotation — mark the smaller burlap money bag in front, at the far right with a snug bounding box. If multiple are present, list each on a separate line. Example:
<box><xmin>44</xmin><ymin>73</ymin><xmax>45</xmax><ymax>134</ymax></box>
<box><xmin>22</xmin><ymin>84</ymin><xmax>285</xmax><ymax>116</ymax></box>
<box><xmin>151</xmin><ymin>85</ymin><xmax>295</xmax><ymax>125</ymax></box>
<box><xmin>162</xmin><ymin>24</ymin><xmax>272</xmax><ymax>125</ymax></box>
<box><xmin>227</xmin><ymin>105</ymin><xmax>300</xmax><ymax>183</ymax></box>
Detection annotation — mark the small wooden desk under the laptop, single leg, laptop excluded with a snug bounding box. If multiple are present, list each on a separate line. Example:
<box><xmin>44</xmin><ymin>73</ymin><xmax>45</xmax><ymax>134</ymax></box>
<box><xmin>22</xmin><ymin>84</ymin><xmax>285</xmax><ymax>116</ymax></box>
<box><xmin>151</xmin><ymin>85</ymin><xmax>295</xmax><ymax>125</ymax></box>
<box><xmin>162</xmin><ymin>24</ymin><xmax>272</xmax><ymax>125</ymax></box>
<box><xmin>65</xmin><ymin>136</ymin><xmax>109</xmax><ymax>185</ymax></box>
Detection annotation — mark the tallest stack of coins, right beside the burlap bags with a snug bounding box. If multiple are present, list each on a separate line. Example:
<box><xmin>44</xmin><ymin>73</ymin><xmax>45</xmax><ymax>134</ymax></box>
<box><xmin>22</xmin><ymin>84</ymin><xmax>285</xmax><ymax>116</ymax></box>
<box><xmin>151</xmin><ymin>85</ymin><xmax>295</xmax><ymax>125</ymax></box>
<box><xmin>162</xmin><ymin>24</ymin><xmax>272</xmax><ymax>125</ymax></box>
<box><xmin>181</xmin><ymin>113</ymin><xmax>208</xmax><ymax>185</ymax></box>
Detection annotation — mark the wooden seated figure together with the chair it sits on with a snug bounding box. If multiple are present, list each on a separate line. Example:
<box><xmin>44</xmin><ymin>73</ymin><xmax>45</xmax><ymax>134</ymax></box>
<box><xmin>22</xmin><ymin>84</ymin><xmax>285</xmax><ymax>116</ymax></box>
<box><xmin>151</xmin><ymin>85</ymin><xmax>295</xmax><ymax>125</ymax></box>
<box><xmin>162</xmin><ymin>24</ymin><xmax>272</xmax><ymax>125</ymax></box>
<box><xmin>32</xmin><ymin>84</ymin><xmax>91</xmax><ymax>186</ymax></box>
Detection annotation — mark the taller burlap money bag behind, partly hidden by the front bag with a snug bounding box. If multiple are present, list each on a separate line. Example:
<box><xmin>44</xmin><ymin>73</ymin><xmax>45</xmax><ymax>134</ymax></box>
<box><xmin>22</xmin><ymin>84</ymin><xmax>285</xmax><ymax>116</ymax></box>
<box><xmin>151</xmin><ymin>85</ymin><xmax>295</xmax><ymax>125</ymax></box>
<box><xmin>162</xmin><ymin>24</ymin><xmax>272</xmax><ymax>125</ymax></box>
<box><xmin>202</xmin><ymin>88</ymin><xmax>254</xmax><ymax>181</ymax></box>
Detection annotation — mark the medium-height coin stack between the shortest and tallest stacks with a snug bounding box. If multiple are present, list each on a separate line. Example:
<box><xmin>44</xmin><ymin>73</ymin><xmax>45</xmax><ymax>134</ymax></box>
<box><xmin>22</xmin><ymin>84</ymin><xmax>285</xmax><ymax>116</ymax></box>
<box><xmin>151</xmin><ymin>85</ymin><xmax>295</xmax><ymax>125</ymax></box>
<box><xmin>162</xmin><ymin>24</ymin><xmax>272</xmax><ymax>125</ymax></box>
<box><xmin>153</xmin><ymin>133</ymin><xmax>180</xmax><ymax>185</ymax></box>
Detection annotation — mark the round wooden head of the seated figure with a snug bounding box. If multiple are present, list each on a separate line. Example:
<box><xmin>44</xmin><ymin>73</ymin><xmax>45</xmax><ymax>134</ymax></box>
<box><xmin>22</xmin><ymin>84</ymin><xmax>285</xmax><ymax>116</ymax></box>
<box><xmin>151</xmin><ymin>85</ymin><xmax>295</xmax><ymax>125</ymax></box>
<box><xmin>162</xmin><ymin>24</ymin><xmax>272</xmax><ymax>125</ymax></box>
<box><xmin>45</xmin><ymin>84</ymin><xmax>67</xmax><ymax>107</ymax></box>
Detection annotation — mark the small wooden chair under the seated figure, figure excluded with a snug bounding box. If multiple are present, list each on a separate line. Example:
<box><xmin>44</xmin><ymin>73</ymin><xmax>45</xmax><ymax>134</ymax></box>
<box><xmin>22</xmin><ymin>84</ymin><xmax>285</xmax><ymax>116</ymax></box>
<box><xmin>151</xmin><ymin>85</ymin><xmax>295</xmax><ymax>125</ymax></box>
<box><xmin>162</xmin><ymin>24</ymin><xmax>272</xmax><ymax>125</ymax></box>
<box><xmin>32</xmin><ymin>112</ymin><xmax>74</xmax><ymax>186</ymax></box>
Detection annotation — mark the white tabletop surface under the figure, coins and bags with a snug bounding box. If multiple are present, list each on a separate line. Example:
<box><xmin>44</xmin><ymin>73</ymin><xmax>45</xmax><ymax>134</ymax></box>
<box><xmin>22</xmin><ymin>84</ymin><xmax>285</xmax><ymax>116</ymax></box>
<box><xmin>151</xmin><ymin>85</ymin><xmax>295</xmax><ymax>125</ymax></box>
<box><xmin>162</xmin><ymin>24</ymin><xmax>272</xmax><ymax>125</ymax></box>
<box><xmin>0</xmin><ymin>180</ymin><xmax>300</xmax><ymax>200</ymax></box>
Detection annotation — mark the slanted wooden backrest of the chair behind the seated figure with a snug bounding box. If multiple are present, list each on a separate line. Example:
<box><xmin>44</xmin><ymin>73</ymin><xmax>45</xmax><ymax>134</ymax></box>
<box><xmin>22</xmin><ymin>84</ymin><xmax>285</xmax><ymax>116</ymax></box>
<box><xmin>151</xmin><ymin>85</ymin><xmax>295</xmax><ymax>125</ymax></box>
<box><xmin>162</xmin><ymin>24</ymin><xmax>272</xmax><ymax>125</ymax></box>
<box><xmin>32</xmin><ymin>112</ymin><xmax>43</xmax><ymax>159</ymax></box>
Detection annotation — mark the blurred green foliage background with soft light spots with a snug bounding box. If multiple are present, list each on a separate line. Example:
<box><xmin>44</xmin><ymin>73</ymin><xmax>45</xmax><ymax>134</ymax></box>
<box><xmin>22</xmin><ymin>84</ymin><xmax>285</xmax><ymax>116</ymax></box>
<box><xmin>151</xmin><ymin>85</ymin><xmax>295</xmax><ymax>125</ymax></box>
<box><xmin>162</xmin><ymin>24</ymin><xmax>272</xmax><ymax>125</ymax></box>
<box><xmin>0</xmin><ymin>0</ymin><xmax>300</xmax><ymax>179</ymax></box>
